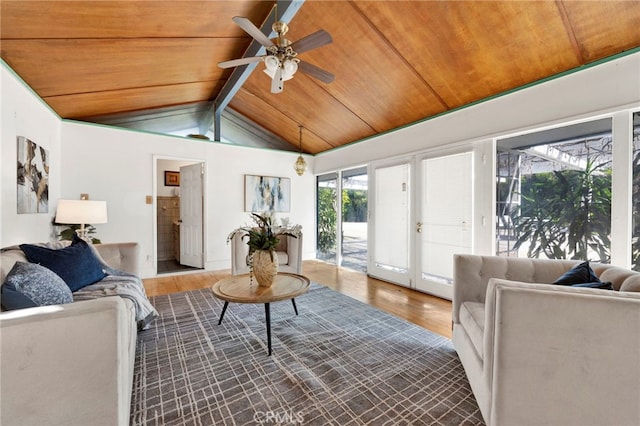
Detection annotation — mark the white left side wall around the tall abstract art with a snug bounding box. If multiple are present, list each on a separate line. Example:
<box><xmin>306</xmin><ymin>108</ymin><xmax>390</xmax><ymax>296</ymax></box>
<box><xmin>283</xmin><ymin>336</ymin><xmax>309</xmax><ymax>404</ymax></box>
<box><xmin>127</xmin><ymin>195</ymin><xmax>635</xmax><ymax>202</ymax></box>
<box><xmin>0</xmin><ymin>61</ymin><xmax>61</xmax><ymax>247</ymax></box>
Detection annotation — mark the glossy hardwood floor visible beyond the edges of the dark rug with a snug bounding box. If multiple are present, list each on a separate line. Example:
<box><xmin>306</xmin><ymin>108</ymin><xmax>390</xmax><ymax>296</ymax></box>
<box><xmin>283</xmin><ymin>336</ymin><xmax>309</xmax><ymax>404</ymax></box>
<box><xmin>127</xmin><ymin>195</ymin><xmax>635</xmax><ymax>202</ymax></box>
<box><xmin>143</xmin><ymin>260</ymin><xmax>451</xmax><ymax>338</ymax></box>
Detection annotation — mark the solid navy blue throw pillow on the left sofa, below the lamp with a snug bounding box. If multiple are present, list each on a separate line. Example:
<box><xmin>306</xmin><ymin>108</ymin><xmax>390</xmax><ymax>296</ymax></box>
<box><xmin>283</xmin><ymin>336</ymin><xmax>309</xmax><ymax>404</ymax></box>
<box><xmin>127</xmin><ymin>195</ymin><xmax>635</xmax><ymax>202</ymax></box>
<box><xmin>20</xmin><ymin>239</ymin><xmax>106</xmax><ymax>292</ymax></box>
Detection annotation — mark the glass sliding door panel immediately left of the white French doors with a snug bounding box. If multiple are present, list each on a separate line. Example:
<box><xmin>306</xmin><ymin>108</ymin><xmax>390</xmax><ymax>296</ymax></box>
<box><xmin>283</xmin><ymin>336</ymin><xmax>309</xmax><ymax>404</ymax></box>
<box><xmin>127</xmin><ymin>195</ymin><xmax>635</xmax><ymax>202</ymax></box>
<box><xmin>340</xmin><ymin>167</ymin><xmax>369</xmax><ymax>272</ymax></box>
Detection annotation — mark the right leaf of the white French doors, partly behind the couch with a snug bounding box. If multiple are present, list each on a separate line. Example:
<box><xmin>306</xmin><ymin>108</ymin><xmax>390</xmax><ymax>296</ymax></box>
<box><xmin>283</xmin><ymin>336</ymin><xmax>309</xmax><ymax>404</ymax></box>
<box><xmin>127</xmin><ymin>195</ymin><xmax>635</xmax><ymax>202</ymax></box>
<box><xmin>415</xmin><ymin>152</ymin><xmax>473</xmax><ymax>300</ymax></box>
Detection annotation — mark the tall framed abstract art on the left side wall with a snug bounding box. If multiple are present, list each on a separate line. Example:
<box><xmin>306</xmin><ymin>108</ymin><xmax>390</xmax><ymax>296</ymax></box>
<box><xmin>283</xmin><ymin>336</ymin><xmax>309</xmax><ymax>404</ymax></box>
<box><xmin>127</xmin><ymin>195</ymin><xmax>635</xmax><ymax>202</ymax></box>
<box><xmin>17</xmin><ymin>136</ymin><xmax>49</xmax><ymax>214</ymax></box>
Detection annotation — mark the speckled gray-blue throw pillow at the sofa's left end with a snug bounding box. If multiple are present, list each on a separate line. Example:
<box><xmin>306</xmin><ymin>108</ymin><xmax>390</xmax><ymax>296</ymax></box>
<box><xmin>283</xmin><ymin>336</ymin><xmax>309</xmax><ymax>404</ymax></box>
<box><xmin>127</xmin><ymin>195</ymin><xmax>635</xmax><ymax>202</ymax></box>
<box><xmin>2</xmin><ymin>262</ymin><xmax>73</xmax><ymax>310</ymax></box>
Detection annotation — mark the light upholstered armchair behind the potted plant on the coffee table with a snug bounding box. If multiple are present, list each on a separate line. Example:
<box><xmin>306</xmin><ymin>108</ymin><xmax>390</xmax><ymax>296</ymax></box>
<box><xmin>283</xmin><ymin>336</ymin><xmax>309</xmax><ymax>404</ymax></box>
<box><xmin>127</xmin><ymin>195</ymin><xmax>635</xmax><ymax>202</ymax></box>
<box><xmin>229</xmin><ymin>232</ymin><xmax>302</xmax><ymax>275</ymax></box>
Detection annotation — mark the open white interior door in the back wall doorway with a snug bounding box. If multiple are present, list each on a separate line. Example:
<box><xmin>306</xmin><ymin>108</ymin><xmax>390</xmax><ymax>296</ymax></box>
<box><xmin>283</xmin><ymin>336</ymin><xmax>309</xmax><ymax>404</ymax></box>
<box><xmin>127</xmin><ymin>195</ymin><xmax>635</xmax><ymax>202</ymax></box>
<box><xmin>180</xmin><ymin>163</ymin><xmax>204</xmax><ymax>268</ymax></box>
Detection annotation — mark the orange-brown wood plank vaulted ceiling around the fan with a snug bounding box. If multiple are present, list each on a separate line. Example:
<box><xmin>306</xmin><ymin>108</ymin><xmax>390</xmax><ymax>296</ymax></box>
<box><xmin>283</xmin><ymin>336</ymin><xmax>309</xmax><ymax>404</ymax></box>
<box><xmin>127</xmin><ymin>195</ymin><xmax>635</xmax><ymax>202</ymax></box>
<box><xmin>0</xmin><ymin>0</ymin><xmax>640</xmax><ymax>154</ymax></box>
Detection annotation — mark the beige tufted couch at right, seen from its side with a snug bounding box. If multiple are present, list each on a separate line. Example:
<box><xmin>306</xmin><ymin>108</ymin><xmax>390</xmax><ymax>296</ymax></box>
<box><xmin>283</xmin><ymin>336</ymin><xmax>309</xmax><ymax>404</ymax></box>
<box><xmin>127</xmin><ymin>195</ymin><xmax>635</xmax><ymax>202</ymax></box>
<box><xmin>452</xmin><ymin>255</ymin><xmax>640</xmax><ymax>426</ymax></box>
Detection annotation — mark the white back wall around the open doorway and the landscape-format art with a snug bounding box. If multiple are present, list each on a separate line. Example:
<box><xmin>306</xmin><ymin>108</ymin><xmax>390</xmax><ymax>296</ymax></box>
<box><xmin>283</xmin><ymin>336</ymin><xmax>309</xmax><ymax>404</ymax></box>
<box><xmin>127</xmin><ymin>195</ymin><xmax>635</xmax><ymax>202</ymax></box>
<box><xmin>61</xmin><ymin>121</ymin><xmax>315</xmax><ymax>277</ymax></box>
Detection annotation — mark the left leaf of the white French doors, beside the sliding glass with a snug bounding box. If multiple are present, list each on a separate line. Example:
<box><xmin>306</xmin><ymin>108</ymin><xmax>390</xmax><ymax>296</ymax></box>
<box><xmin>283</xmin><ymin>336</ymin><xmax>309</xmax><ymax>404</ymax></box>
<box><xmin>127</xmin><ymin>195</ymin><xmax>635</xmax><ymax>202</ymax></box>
<box><xmin>367</xmin><ymin>162</ymin><xmax>412</xmax><ymax>286</ymax></box>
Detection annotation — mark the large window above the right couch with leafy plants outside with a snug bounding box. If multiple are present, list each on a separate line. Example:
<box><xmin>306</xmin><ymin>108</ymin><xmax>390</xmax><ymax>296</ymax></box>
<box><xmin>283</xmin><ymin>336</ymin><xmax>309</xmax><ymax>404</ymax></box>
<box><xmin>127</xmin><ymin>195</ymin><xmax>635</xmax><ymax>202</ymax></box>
<box><xmin>496</xmin><ymin>119</ymin><xmax>612</xmax><ymax>263</ymax></box>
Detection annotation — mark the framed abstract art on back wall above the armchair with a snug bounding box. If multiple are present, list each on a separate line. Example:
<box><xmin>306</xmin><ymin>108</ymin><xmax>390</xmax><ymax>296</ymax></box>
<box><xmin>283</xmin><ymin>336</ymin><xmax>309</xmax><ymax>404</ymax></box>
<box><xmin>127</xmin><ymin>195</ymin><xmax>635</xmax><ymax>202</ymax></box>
<box><xmin>244</xmin><ymin>175</ymin><xmax>291</xmax><ymax>212</ymax></box>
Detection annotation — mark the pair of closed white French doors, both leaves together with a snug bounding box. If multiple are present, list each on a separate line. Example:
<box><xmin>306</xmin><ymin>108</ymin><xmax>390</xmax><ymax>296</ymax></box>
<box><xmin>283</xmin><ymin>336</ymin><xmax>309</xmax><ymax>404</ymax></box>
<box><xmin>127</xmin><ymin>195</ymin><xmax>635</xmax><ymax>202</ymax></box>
<box><xmin>368</xmin><ymin>152</ymin><xmax>473</xmax><ymax>299</ymax></box>
